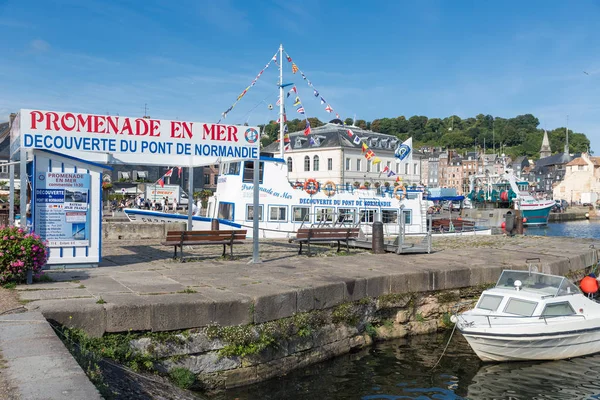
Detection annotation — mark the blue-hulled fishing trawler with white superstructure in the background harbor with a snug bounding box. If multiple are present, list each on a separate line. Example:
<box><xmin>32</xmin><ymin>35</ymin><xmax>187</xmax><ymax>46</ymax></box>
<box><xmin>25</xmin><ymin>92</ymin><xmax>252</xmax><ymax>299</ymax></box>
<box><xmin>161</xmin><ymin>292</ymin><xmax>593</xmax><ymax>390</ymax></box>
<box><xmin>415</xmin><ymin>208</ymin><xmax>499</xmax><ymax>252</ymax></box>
<box><xmin>468</xmin><ymin>168</ymin><xmax>554</xmax><ymax>226</ymax></box>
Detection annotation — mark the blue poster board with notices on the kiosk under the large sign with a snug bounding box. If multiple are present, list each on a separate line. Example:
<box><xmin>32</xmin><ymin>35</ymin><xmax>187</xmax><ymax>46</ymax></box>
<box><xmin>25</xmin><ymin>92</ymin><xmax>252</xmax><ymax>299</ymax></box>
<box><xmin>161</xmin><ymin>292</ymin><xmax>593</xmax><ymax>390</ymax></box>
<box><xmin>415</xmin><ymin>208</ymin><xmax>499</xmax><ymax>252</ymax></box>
<box><xmin>34</xmin><ymin>172</ymin><xmax>91</xmax><ymax>247</ymax></box>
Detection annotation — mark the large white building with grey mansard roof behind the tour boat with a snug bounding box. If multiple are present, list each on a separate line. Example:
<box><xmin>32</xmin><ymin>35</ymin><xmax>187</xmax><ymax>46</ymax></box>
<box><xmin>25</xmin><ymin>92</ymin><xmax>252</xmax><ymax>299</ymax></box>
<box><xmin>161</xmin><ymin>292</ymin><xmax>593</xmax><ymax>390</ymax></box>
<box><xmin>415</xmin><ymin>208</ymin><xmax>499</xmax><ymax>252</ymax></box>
<box><xmin>262</xmin><ymin>123</ymin><xmax>423</xmax><ymax>187</ymax></box>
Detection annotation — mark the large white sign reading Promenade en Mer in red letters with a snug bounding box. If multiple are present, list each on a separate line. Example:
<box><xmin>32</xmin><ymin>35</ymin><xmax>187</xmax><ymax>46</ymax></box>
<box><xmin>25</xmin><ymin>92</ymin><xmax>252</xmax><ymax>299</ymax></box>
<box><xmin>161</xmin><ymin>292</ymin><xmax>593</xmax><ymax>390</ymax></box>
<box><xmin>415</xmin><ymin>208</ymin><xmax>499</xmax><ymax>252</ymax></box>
<box><xmin>13</xmin><ymin>110</ymin><xmax>260</xmax><ymax>166</ymax></box>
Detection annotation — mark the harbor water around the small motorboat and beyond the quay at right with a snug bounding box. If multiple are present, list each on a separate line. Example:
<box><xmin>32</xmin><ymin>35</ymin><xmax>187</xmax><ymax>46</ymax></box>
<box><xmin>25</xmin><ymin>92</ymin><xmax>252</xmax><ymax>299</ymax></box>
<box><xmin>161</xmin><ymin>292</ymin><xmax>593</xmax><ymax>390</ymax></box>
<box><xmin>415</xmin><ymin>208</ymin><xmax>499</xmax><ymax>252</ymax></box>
<box><xmin>210</xmin><ymin>220</ymin><xmax>600</xmax><ymax>400</ymax></box>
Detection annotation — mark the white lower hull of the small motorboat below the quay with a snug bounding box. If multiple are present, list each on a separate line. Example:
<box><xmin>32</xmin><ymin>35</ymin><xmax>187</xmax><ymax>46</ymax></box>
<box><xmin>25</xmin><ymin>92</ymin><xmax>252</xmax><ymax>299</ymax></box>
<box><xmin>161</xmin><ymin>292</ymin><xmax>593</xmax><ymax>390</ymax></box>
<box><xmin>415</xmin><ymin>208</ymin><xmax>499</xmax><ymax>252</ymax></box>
<box><xmin>463</xmin><ymin>326</ymin><xmax>600</xmax><ymax>362</ymax></box>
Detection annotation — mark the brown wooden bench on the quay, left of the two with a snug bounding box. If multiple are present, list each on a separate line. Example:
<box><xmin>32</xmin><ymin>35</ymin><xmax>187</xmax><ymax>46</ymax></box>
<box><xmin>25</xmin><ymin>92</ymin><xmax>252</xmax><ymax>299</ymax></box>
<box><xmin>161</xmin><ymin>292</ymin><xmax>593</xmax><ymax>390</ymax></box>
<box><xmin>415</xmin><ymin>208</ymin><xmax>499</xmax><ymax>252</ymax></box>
<box><xmin>161</xmin><ymin>229</ymin><xmax>246</xmax><ymax>261</ymax></box>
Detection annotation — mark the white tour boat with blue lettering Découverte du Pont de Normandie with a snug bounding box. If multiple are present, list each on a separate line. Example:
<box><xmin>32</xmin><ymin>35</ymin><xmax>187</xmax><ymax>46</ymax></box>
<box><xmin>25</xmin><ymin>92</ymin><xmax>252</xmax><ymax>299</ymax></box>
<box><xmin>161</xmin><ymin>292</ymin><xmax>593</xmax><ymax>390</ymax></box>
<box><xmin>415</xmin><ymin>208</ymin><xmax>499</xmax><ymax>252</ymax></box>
<box><xmin>123</xmin><ymin>156</ymin><xmax>428</xmax><ymax>238</ymax></box>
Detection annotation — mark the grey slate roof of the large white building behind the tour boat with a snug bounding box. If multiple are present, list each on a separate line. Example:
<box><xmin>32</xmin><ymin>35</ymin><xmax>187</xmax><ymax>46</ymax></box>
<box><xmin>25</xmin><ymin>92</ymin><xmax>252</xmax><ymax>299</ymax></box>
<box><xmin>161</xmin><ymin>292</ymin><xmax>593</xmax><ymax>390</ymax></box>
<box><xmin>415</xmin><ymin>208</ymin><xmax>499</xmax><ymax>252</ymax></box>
<box><xmin>261</xmin><ymin>123</ymin><xmax>404</xmax><ymax>155</ymax></box>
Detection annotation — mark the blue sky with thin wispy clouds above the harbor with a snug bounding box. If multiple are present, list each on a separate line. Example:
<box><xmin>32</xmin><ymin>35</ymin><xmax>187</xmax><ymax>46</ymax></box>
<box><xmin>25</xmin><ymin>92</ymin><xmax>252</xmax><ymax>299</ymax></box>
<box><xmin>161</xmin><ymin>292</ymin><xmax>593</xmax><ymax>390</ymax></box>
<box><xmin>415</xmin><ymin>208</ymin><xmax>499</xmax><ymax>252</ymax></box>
<box><xmin>0</xmin><ymin>0</ymin><xmax>600</xmax><ymax>153</ymax></box>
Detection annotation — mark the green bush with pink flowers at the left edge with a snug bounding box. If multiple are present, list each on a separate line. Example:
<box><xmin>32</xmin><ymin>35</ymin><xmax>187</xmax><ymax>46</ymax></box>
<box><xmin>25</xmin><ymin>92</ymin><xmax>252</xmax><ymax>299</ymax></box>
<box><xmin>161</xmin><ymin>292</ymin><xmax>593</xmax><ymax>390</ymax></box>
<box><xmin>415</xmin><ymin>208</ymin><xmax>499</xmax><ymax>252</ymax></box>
<box><xmin>0</xmin><ymin>226</ymin><xmax>47</xmax><ymax>284</ymax></box>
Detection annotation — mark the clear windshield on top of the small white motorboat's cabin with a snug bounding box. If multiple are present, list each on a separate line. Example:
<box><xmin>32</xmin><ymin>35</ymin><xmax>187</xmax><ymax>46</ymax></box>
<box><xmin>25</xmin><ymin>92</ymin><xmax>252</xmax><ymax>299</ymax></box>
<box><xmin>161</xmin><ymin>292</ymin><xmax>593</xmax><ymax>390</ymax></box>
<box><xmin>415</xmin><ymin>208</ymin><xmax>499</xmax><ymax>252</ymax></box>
<box><xmin>496</xmin><ymin>270</ymin><xmax>581</xmax><ymax>297</ymax></box>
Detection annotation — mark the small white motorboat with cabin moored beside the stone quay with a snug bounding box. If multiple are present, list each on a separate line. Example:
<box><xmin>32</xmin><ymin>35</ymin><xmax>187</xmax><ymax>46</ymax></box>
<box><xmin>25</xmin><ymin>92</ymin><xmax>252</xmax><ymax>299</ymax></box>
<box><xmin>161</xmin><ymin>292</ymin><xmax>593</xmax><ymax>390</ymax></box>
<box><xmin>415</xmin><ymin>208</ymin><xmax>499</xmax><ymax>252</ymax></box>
<box><xmin>452</xmin><ymin>270</ymin><xmax>600</xmax><ymax>361</ymax></box>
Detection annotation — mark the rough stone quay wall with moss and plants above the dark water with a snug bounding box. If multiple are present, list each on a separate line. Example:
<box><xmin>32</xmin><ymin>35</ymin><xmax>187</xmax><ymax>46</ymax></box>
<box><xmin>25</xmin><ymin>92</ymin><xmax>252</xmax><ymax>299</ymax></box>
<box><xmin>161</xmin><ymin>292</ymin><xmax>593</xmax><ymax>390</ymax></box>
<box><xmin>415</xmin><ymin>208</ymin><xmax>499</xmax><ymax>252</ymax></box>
<box><xmin>131</xmin><ymin>288</ymin><xmax>483</xmax><ymax>390</ymax></box>
